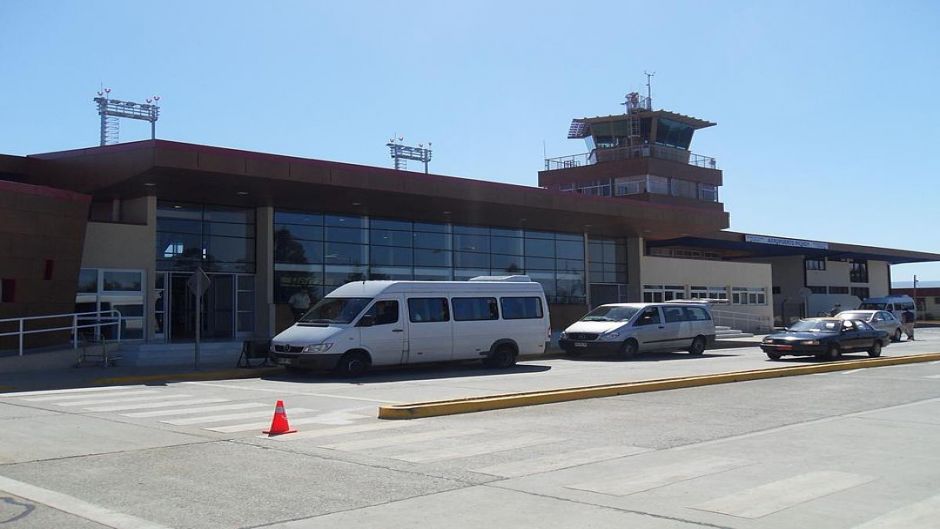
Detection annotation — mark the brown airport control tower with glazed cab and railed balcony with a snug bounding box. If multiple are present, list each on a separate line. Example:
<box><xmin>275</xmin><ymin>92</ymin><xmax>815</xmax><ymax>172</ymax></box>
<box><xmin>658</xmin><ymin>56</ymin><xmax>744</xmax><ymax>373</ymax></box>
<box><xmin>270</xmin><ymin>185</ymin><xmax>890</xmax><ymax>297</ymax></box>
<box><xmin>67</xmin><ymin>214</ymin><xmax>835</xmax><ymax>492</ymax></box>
<box><xmin>539</xmin><ymin>92</ymin><xmax>723</xmax><ymax>211</ymax></box>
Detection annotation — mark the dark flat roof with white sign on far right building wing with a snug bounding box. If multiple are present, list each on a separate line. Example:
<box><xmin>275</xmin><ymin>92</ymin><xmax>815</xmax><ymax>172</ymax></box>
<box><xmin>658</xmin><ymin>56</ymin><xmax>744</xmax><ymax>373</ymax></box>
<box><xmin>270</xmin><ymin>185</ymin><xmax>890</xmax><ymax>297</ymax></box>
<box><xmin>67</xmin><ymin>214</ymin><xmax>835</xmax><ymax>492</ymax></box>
<box><xmin>648</xmin><ymin>231</ymin><xmax>940</xmax><ymax>264</ymax></box>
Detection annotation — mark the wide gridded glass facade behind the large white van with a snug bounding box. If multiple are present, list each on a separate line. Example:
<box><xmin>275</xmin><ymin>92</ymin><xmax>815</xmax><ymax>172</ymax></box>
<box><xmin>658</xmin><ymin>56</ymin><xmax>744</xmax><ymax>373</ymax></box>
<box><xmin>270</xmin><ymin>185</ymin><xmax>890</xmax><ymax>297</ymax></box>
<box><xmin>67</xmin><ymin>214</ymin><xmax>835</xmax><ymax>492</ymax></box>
<box><xmin>274</xmin><ymin>210</ymin><xmax>585</xmax><ymax>304</ymax></box>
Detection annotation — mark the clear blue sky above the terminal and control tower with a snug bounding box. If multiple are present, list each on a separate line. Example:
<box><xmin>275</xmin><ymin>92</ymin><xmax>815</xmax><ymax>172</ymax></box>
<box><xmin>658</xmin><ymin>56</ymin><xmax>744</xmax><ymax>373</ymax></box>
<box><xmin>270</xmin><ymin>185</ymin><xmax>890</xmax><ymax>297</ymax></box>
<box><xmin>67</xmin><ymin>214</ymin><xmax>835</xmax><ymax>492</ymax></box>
<box><xmin>0</xmin><ymin>0</ymin><xmax>940</xmax><ymax>280</ymax></box>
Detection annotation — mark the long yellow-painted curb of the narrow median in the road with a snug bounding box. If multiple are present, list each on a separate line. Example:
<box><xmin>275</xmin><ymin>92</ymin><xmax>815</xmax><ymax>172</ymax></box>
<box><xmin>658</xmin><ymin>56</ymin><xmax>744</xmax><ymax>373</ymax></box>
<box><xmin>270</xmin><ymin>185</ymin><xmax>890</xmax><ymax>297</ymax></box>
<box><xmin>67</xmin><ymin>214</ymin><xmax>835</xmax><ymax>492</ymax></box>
<box><xmin>379</xmin><ymin>353</ymin><xmax>940</xmax><ymax>419</ymax></box>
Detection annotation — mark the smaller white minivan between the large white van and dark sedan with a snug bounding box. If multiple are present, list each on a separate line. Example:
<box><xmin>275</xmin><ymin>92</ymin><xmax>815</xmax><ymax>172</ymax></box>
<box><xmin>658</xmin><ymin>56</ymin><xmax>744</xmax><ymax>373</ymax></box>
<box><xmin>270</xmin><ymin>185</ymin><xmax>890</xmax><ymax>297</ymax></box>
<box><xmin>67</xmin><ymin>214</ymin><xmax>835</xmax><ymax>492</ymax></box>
<box><xmin>558</xmin><ymin>302</ymin><xmax>715</xmax><ymax>358</ymax></box>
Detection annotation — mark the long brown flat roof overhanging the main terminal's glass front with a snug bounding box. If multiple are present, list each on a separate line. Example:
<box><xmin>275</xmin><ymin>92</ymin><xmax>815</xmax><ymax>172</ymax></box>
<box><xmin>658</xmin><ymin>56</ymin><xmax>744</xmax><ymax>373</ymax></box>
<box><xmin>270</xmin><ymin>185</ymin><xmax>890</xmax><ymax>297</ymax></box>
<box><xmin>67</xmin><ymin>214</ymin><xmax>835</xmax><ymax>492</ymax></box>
<box><xmin>18</xmin><ymin>140</ymin><xmax>728</xmax><ymax>239</ymax></box>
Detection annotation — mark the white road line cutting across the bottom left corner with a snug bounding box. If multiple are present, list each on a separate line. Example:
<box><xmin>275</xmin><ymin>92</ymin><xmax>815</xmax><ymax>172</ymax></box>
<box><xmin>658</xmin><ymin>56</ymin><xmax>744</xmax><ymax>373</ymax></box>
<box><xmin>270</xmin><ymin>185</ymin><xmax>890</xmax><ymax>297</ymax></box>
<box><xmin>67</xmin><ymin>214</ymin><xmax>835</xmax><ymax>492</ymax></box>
<box><xmin>0</xmin><ymin>476</ymin><xmax>170</xmax><ymax>529</ymax></box>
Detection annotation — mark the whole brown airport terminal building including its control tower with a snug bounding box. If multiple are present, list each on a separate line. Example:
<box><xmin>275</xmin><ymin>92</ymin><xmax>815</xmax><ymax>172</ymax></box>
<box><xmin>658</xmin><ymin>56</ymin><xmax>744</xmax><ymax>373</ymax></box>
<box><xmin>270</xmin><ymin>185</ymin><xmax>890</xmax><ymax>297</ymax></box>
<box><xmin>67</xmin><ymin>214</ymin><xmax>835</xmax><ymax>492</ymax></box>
<box><xmin>0</xmin><ymin>99</ymin><xmax>940</xmax><ymax>349</ymax></box>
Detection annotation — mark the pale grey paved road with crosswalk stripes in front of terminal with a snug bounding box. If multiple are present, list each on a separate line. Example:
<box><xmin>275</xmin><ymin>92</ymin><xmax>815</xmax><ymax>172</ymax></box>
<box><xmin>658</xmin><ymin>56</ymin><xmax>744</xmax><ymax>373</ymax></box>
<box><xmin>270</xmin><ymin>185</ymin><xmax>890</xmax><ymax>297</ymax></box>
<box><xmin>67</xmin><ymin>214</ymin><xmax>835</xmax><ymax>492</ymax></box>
<box><xmin>0</xmin><ymin>329</ymin><xmax>940</xmax><ymax>529</ymax></box>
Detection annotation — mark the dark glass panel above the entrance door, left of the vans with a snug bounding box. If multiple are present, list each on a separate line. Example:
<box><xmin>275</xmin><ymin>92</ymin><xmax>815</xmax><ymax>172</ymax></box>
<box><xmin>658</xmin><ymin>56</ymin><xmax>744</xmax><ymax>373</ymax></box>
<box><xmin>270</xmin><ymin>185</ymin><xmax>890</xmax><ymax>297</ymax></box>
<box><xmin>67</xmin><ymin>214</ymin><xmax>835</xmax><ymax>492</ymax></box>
<box><xmin>157</xmin><ymin>202</ymin><xmax>255</xmax><ymax>273</ymax></box>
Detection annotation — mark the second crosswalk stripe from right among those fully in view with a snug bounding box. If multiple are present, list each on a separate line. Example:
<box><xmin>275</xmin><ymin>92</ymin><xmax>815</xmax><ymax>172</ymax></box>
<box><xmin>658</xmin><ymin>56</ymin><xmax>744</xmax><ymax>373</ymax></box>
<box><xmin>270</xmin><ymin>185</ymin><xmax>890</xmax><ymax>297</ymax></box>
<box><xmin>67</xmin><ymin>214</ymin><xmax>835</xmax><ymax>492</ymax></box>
<box><xmin>567</xmin><ymin>457</ymin><xmax>750</xmax><ymax>496</ymax></box>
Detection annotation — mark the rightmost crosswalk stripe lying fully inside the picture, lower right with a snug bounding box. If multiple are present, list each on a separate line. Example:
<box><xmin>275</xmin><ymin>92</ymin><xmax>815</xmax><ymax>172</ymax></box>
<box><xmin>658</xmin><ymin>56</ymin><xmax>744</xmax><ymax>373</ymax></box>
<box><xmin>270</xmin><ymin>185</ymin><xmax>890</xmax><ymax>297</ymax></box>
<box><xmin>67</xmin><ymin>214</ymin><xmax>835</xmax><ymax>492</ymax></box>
<box><xmin>693</xmin><ymin>471</ymin><xmax>875</xmax><ymax>518</ymax></box>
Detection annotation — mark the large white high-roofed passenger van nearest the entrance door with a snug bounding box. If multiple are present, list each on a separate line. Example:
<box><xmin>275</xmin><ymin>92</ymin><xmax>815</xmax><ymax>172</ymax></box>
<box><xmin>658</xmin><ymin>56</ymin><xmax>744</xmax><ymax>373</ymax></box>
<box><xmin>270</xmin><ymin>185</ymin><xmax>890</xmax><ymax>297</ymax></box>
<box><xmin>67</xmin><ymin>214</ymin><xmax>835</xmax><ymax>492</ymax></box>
<box><xmin>270</xmin><ymin>276</ymin><xmax>551</xmax><ymax>376</ymax></box>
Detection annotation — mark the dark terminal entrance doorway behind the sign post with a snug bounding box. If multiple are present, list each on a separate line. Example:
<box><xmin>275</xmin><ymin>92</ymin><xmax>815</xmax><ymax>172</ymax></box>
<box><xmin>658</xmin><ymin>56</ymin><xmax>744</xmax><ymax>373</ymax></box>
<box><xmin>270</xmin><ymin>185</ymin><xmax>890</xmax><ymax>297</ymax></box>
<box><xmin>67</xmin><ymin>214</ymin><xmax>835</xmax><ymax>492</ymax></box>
<box><xmin>168</xmin><ymin>272</ymin><xmax>237</xmax><ymax>342</ymax></box>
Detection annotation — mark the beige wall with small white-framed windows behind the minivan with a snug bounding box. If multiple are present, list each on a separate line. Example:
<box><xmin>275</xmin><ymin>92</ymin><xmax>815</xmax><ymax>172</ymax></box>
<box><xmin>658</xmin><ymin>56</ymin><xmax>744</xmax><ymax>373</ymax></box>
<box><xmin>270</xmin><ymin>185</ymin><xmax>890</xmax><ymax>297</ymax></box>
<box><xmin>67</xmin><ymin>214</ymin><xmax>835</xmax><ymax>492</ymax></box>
<box><xmin>640</xmin><ymin>256</ymin><xmax>773</xmax><ymax>332</ymax></box>
